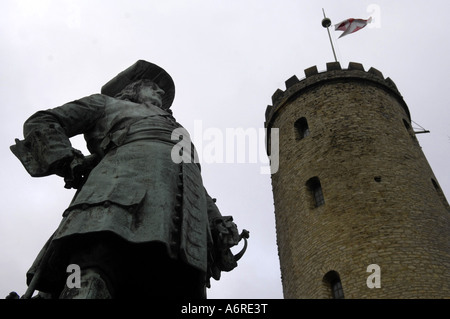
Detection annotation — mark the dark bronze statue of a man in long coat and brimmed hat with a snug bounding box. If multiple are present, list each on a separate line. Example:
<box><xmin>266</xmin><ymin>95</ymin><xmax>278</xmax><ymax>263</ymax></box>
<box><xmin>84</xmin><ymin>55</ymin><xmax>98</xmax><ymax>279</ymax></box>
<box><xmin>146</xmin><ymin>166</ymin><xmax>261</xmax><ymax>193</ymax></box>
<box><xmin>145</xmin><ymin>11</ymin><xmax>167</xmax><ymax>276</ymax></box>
<box><xmin>11</xmin><ymin>60</ymin><xmax>248</xmax><ymax>299</ymax></box>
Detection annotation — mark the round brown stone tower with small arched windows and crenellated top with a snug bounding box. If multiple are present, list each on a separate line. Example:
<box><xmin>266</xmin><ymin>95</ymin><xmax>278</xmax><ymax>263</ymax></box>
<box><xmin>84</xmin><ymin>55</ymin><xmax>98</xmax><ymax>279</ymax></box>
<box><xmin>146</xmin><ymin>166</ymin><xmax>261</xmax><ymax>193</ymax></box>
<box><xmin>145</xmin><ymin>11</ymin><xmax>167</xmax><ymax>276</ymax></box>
<box><xmin>265</xmin><ymin>62</ymin><xmax>450</xmax><ymax>298</ymax></box>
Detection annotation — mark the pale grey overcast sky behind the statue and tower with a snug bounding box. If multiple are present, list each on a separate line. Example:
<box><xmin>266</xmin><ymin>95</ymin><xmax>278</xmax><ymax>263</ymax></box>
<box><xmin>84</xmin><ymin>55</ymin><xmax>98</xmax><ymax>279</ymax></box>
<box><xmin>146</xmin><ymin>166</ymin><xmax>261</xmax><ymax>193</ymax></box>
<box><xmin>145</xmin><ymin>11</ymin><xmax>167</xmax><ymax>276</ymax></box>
<box><xmin>0</xmin><ymin>0</ymin><xmax>450</xmax><ymax>298</ymax></box>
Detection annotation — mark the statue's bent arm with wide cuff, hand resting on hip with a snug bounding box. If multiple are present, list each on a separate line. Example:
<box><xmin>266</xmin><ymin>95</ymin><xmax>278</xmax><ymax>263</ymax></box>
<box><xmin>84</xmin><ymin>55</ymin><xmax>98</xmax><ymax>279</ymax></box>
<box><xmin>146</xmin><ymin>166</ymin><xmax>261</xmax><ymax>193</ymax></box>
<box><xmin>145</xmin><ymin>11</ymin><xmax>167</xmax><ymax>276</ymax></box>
<box><xmin>11</xmin><ymin>94</ymin><xmax>105</xmax><ymax>181</ymax></box>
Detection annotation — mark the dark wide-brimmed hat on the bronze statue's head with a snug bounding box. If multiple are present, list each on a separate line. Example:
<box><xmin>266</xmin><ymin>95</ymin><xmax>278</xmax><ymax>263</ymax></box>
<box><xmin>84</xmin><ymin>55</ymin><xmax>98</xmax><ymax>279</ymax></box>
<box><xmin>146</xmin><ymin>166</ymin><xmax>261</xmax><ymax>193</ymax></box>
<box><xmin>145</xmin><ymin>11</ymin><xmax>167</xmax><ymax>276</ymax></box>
<box><xmin>101</xmin><ymin>60</ymin><xmax>175</xmax><ymax>108</ymax></box>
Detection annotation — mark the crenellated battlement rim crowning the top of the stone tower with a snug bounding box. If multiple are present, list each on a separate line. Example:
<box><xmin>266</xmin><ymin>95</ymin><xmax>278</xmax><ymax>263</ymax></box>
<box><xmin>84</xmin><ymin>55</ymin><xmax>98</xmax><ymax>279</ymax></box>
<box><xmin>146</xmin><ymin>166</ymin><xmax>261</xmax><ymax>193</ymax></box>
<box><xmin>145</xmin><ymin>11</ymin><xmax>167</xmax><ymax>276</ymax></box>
<box><xmin>266</xmin><ymin>62</ymin><xmax>411</xmax><ymax>126</ymax></box>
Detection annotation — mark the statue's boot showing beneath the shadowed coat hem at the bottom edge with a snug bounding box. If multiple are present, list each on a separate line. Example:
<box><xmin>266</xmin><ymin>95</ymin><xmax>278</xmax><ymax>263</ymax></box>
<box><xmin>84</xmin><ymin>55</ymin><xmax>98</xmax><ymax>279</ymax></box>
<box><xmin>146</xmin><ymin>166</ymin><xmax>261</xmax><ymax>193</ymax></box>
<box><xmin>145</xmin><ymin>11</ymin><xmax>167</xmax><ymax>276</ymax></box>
<box><xmin>60</xmin><ymin>268</ymin><xmax>112</xmax><ymax>299</ymax></box>
